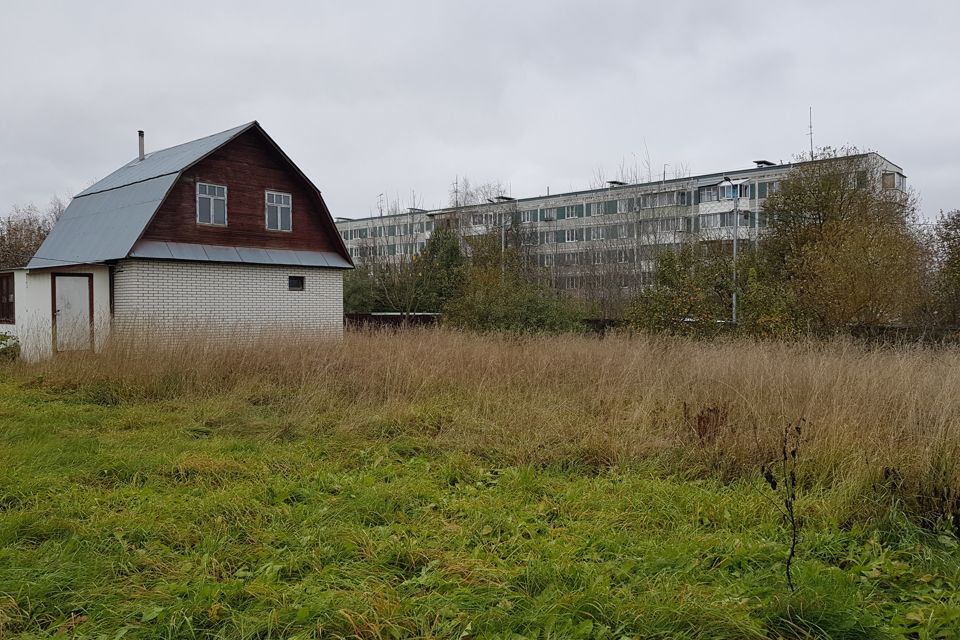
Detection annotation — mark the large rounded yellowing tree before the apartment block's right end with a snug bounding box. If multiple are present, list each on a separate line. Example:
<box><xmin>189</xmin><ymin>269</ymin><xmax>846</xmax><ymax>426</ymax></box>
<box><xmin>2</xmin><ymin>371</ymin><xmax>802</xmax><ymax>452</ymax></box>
<box><xmin>760</xmin><ymin>148</ymin><xmax>925</xmax><ymax>331</ymax></box>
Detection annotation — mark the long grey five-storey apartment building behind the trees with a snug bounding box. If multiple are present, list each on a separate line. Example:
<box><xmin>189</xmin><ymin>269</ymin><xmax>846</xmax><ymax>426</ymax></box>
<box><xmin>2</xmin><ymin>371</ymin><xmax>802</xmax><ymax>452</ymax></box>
<box><xmin>337</xmin><ymin>153</ymin><xmax>906</xmax><ymax>308</ymax></box>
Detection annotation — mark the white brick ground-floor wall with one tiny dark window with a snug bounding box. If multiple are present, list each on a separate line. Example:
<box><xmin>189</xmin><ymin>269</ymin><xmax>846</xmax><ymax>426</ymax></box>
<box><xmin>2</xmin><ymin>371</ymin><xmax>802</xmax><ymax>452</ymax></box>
<box><xmin>114</xmin><ymin>260</ymin><xmax>343</xmax><ymax>337</ymax></box>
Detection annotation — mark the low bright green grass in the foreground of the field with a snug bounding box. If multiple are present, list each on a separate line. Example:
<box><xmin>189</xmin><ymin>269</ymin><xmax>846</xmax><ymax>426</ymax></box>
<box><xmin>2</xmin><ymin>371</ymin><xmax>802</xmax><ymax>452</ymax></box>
<box><xmin>0</xmin><ymin>374</ymin><xmax>960</xmax><ymax>639</ymax></box>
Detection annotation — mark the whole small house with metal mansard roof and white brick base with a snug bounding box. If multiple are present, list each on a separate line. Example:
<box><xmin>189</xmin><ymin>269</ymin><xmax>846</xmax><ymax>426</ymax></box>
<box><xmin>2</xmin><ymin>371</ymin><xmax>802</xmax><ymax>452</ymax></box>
<box><xmin>0</xmin><ymin>122</ymin><xmax>353</xmax><ymax>359</ymax></box>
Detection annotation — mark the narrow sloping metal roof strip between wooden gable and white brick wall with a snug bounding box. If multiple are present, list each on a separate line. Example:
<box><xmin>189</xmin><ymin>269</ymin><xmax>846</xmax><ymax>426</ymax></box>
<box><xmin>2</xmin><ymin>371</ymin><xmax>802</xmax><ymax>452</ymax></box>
<box><xmin>130</xmin><ymin>240</ymin><xmax>352</xmax><ymax>269</ymax></box>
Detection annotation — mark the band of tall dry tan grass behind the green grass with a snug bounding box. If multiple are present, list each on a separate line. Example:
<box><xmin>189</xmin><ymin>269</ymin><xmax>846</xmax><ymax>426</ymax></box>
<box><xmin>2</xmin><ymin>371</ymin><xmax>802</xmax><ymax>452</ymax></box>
<box><xmin>20</xmin><ymin>330</ymin><xmax>960</xmax><ymax>521</ymax></box>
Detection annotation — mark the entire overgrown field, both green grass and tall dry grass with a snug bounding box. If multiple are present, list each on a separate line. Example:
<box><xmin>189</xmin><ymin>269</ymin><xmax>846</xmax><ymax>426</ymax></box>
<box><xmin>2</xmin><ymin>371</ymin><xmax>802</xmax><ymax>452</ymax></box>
<box><xmin>0</xmin><ymin>331</ymin><xmax>960</xmax><ymax>639</ymax></box>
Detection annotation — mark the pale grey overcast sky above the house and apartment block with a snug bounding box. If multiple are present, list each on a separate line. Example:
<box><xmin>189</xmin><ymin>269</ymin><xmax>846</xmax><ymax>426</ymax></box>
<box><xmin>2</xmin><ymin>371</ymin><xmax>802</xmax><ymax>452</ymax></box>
<box><xmin>0</xmin><ymin>0</ymin><xmax>960</xmax><ymax>217</ymax></box>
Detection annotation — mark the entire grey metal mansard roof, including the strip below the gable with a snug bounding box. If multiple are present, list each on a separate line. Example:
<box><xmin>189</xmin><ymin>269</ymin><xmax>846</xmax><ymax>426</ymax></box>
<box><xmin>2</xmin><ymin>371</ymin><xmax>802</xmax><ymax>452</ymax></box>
<box><xmin>26</xmin><ymin>121</ymin><xmax>353</xmax><ymax>269</ymax></box>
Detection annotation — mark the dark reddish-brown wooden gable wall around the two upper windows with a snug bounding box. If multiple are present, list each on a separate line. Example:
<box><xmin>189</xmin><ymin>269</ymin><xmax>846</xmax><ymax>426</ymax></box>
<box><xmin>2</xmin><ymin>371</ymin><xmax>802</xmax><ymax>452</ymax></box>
<box><xmin>141</xmin><ymin>125</ymin><xmax>350</xmax><ymax>260</ymax></box>
